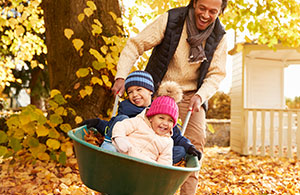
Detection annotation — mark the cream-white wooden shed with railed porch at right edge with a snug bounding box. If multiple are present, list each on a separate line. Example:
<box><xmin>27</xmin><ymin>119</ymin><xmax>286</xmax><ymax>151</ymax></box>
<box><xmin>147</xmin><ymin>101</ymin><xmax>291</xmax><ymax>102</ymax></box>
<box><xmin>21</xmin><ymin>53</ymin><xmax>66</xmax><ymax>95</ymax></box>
<box><xmin>229</xmin><ymin>43</ymin><xmax>300</xmax><ymax>158</ymax></box>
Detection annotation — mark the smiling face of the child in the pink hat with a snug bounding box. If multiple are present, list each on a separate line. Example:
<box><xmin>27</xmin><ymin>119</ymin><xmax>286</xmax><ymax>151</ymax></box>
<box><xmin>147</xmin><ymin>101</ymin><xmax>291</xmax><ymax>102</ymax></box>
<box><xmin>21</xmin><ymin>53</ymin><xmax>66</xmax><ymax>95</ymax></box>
<box><xmin>149</xmin><ymin>114</ymin><xmax>174</xmax><ymax>135</ymax></box>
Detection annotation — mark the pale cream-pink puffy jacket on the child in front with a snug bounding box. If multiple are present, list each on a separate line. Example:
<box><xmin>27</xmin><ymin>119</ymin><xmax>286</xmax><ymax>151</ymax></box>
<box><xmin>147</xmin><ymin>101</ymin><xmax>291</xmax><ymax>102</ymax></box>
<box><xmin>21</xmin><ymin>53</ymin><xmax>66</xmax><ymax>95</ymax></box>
<box><xmin>112</xmin><ymin>109</ymin><xmax>173</xmax><ymax>165</ymax></box>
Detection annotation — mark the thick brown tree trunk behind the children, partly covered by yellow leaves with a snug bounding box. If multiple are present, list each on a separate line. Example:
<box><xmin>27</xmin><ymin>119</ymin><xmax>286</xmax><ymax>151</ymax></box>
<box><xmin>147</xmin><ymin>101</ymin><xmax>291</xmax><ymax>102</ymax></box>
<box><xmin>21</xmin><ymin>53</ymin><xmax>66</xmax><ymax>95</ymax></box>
<box><xmin>42</xmin><ymin>0</ymin><xmax>121</xmax><ymax>126</ymax></box>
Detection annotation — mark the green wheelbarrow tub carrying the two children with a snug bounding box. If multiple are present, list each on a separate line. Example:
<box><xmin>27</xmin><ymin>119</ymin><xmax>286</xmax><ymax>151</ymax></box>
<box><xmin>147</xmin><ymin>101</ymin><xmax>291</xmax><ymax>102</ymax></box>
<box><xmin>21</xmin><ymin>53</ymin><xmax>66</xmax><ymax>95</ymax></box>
<box><xmin>68</xmin><ymin>126</ymin><xmax>200</xmax><ymax>195</ymax></box>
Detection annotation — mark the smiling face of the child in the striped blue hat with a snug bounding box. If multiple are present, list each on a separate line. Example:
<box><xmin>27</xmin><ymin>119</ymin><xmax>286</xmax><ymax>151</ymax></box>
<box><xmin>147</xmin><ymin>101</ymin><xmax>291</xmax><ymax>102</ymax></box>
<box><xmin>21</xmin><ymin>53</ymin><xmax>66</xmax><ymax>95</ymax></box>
<box><xmin>127</xmin><ymin>86</ymin><xmax>152</xmax><ymax>107</ymax></box>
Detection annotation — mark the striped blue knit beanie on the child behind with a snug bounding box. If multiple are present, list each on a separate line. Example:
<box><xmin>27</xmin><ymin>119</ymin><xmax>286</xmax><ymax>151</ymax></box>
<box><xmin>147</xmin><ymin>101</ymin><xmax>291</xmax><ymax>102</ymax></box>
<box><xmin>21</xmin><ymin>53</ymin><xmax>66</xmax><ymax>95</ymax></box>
<box><xmin>125</xmin><ymin>70</ymin><xmax>154</xmax><ymax>92</ymax></box>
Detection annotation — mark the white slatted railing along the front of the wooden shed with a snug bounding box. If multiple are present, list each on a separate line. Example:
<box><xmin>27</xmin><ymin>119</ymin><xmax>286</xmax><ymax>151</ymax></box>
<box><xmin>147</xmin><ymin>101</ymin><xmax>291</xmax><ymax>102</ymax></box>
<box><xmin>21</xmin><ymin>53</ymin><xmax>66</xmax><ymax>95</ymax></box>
<box><xmin>244</xmin><ymin>109</ymin><xmax>300</xmax><ymax>159</ymax></box>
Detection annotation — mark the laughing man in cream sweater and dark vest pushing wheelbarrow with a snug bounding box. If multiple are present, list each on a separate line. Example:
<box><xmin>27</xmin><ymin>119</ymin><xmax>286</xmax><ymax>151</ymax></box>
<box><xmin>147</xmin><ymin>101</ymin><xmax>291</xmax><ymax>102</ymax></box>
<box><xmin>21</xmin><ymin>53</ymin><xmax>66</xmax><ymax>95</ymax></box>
<box><xmin>112</xmin><ymin>0</ymin><xmax>227</xmax><ymax>195</ymax></box>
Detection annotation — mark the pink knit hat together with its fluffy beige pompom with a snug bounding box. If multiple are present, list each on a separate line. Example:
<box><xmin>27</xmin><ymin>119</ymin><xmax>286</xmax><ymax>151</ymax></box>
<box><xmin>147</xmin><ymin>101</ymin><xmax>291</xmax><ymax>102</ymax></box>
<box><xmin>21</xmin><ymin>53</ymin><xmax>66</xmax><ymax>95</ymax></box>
<box><xmin>146</xmin><ymin>81</ymin><xmax>182</xmax><ymax>127</ymax></box>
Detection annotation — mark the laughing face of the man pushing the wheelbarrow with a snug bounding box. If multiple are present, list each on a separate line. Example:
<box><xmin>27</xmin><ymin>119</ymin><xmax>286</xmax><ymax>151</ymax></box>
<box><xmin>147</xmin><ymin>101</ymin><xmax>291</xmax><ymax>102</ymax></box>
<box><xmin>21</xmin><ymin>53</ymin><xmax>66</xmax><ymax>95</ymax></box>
<box><xmin>193</xmin><ymin>0</ymin><xmax>222</xmax><ymax>30</ymax></box>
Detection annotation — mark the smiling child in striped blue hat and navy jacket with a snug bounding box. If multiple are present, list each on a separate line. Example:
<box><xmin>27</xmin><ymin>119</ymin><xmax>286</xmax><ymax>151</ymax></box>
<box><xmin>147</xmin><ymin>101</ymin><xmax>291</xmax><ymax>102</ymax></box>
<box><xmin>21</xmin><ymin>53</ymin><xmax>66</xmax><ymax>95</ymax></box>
<box><xmin>80</xmin><ymin>71</ymin><xmax>202</xmax><ymax>164</ymax></box>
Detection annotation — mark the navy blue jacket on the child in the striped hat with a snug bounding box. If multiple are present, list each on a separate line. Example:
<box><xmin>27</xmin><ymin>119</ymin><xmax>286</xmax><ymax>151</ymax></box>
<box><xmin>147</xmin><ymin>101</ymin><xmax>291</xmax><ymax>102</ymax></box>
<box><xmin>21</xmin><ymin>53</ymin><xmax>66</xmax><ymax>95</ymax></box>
<box><xmin>96</xmin><ymin>100</ymin><xmax>192</xmax><ymax>151</ymax></box>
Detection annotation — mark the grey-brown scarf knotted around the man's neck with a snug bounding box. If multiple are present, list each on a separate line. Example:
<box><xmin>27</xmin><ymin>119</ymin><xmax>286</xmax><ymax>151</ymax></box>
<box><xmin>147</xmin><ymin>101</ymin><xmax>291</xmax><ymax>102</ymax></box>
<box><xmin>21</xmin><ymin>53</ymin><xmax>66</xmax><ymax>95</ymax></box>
<box><xmin>186</xmin><ymin>7</ymin><xmax>215</xmax><ymax>62</ymax></box>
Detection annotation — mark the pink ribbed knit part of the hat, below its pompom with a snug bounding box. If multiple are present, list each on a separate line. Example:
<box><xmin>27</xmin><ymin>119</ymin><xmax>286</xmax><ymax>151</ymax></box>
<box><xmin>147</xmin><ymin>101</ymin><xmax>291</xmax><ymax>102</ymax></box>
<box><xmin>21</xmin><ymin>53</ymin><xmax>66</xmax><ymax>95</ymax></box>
<box><xmin>146</xmin><ymin>96</ymin><xmax>178</xmax><ymax>127</ymax></box>
